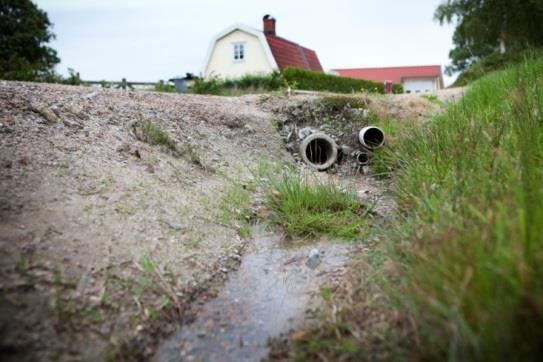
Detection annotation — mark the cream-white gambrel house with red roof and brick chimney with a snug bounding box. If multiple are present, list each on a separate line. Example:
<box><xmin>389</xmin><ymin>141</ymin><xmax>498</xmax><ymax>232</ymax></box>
<box><xmin>202</xmin><ymin>15</ymin><xmax>322</xmax><ymax>78</ymax></box>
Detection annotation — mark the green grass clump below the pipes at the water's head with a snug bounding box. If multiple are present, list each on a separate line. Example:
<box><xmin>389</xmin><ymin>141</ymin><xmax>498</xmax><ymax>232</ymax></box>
<box><xmin>267</xmin><ymin>172</ymin><xmax>370</xmax><ymax>239</ymax></box>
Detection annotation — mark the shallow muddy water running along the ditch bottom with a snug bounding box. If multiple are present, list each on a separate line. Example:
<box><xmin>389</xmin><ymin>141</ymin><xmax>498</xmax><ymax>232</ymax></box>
<box><xmin>153</xmin><ymin>226</ymin><xmax>349</xmax><ymax>362</ymax></box>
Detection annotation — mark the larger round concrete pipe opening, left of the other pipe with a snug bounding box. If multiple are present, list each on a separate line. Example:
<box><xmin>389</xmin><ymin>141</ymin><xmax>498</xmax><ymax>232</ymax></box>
<box><xmin>300</xmin><ymin>133</ymin><xmax>338</xmax><ymax>170</ymax></box>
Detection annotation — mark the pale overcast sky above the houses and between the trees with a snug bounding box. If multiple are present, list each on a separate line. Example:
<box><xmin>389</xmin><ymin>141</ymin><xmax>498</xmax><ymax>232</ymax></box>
<box><xmin>34</xmin><ymin>0</ymin><xmax>460</xmax><ymax>84</ymax></box>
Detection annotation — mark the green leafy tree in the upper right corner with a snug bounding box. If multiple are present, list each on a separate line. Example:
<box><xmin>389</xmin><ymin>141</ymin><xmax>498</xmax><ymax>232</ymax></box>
<box><xmin>434</xmin><ymin>0</ymin><xmax>543</xmax><ymax>73</ymax></box>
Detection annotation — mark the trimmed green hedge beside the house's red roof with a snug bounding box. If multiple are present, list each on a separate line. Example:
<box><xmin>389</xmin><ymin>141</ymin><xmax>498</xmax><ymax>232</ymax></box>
<box><xmin>283</xmin><ymin>67</ymin><xmax>384</xmax><ymax>93</ymax></box>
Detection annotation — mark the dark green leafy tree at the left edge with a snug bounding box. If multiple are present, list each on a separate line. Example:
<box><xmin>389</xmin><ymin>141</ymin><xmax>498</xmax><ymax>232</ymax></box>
<box><xmin>0</xmin><ymin>0</ymin><xmax>60</xmax><ymax>80</ymax></box>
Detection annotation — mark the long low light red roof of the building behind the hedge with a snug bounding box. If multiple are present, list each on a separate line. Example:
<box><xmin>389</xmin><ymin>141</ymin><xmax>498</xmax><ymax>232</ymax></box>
<box><xmin>333</xmin><ymin>65</ymin><xmax>441</xmax><ymax>84</ymax></box>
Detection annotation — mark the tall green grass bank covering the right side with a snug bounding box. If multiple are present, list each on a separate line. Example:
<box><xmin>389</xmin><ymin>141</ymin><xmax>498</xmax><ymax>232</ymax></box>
<box><xmin>387</xmin><ymin>58</ymin><xmax>543</xmax><ymax>360</ymax></box>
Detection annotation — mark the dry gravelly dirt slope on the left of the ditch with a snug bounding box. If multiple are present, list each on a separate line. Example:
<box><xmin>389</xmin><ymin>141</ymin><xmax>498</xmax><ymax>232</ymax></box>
<box><xmin>0</xmin><ymin>82</ymin><xmax>287</xmax><ymax>360</ymax></box>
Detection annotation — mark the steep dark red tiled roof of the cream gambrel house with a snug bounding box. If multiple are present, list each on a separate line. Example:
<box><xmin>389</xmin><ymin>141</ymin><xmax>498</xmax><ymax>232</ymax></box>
<box><xmin>265</xmin><ymin>34</ymin><xmax>322</xmax><ymax>72</ymax></box>
